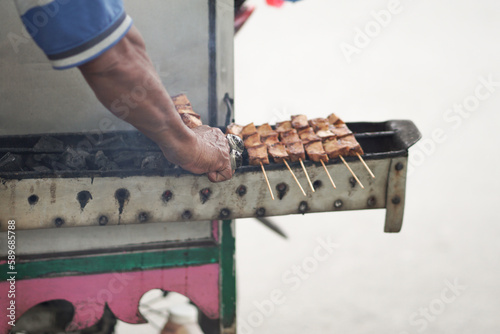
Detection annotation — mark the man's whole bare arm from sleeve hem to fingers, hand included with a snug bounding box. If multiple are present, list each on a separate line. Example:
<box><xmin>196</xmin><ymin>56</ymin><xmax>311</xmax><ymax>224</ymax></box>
<box><xmin>79</xmin><ymin>26</ymin><xmax>232</xmax><ymax>182</ymax></box>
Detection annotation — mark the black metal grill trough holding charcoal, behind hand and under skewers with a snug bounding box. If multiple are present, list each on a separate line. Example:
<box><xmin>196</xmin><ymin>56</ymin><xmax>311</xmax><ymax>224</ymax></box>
<box><xmin>0</xmin><ymin>120</ymin><xmax>421</xmax><ymax>179</ymax></box>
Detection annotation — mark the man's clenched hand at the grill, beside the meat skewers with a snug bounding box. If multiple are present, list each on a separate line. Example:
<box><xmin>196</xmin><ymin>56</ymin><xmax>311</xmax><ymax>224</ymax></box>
<box><xmin>180</xmin><ymin>125</ymin><xmax>234</xmax><ymax>182</ymax></box>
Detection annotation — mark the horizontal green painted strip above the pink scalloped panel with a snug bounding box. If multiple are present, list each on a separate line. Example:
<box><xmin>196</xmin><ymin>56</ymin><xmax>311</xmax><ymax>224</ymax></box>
<box><xmin>0</xmin><ymin>247</ymin><xmax>219</xmax><ymax>281</ymax></box>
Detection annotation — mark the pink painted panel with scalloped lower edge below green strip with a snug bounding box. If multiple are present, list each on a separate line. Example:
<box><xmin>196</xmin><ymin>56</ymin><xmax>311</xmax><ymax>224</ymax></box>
<box><xmin>0</xmin><ymin>264</ymin><xmax>219</xmax><ymax>333</ymax></box>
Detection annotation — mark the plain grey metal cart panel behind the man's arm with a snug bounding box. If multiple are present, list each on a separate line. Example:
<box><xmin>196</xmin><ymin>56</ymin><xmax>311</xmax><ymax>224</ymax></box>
<box><xmin>0</xmin><ymin>0</ymin><xmax>221</xmax><ymax>134</ymax></box>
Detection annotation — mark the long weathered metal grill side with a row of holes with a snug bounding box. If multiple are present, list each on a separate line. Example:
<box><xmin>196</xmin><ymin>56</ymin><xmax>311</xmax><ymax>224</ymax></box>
<box><xmin>0</xmin><ymin>158</ymin><xmax>391</xmax><ymax>231</ymax></box>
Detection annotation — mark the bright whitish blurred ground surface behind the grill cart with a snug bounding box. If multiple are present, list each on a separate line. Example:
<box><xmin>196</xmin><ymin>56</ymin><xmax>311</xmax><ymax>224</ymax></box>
<box><xmin>117</xmin><ymin>0</ymin><xmax>500</xmax><ymax>334</ymax></box>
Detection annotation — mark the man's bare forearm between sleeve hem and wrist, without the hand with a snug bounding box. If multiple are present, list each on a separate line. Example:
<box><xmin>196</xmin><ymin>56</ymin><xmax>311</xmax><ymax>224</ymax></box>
<box><xmin>80</xmin><ymin>27</ymin><xmax>196</xmax><ymax>165</ymax></box>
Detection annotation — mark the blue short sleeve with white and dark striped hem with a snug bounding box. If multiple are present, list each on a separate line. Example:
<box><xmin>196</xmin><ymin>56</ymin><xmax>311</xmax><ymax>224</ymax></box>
<box><xmin>15</xmin><ymin>0</ymin><xmax>132</xmax><ymax>69</ymax></box>
